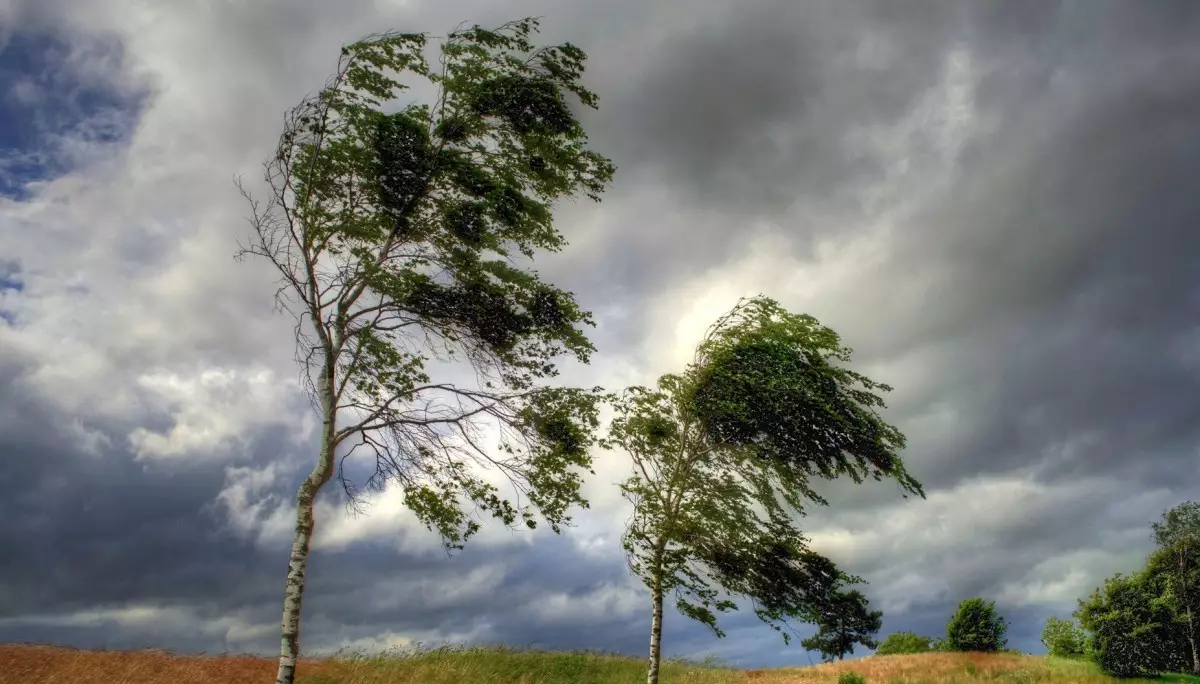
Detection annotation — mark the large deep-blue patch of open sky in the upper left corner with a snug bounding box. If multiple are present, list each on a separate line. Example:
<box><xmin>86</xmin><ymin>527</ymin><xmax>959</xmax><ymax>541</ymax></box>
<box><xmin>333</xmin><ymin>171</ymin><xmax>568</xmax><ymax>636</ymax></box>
<box><xmin>0</xmin><ymin>34</ymin><xmax>144</xmax><ymax>199</ymax></box>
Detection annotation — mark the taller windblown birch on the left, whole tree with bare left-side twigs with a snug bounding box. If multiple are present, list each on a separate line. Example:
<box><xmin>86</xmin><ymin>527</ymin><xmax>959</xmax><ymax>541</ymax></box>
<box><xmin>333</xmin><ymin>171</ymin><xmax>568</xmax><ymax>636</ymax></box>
<box><xmin>239</xmin><ymin>19</ymin><xmax>613</xmax><ymax>684</ymax></box>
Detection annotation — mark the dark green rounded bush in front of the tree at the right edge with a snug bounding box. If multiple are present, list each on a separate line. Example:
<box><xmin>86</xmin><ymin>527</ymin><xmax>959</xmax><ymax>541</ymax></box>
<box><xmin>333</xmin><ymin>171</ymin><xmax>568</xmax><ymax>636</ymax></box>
<box><xmin>1075</xmin><ymin>571</ymin><xmax>1188</xmax><ymax>677</ymax></box>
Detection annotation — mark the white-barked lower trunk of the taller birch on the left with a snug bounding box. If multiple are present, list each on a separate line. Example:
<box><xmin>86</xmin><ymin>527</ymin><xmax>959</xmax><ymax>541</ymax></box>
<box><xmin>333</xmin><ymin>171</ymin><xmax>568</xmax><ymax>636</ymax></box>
<box><xmin>275</xmin><ymin>378</ymin><xmax>336</xmax><ymax>684</ymax></box>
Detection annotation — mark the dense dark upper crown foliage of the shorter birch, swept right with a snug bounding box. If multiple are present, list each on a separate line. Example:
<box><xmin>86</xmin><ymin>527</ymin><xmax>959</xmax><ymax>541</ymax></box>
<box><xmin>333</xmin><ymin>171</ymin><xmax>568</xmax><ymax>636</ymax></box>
<box><xmin>689</xmin><ymin>296</ymin><xmax>924</xmax><ymax>508</ymax></box>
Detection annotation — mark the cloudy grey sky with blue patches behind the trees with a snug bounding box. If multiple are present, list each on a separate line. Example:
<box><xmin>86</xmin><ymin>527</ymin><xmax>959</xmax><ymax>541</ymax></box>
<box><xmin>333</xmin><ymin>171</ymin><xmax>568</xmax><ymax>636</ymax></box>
<box><xmin>0</xmin><ymin>0</ymin><xmax>1200</xmax><ymax>667</ymax></box>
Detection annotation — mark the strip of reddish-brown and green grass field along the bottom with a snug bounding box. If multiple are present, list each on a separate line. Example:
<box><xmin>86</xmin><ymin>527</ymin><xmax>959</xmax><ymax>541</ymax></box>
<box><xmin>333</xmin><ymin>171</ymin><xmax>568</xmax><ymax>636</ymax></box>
<box><xmin>0</xmin><ymin>644</ymin><xmax>1200</xmax><ymax>684</ymax></box>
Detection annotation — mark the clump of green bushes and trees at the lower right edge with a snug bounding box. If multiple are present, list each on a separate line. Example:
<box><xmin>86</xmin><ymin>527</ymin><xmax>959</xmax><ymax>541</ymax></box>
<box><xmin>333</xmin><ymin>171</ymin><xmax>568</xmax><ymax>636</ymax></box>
<box><xmin>1042</xmin><ymin>502</ymin><xmax>1200</xmax><ymax>677</ymax></box>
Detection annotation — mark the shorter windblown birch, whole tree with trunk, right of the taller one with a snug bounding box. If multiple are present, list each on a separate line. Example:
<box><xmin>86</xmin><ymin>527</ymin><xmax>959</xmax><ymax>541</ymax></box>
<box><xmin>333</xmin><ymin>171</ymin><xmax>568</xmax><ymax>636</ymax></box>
<box><xmin>605</xmin><ymin>296</ymin><xmax>924</xmax><ymax>684</ymax></box>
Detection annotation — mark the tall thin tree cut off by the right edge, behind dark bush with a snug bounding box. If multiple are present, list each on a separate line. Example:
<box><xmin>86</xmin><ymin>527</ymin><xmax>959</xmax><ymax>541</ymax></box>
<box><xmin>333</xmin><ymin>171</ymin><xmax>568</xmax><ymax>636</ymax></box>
<box><xmin>1151</xmin><ymin>502</ymin><xmax>1200</xmax><ymax>674</ymax></box>
